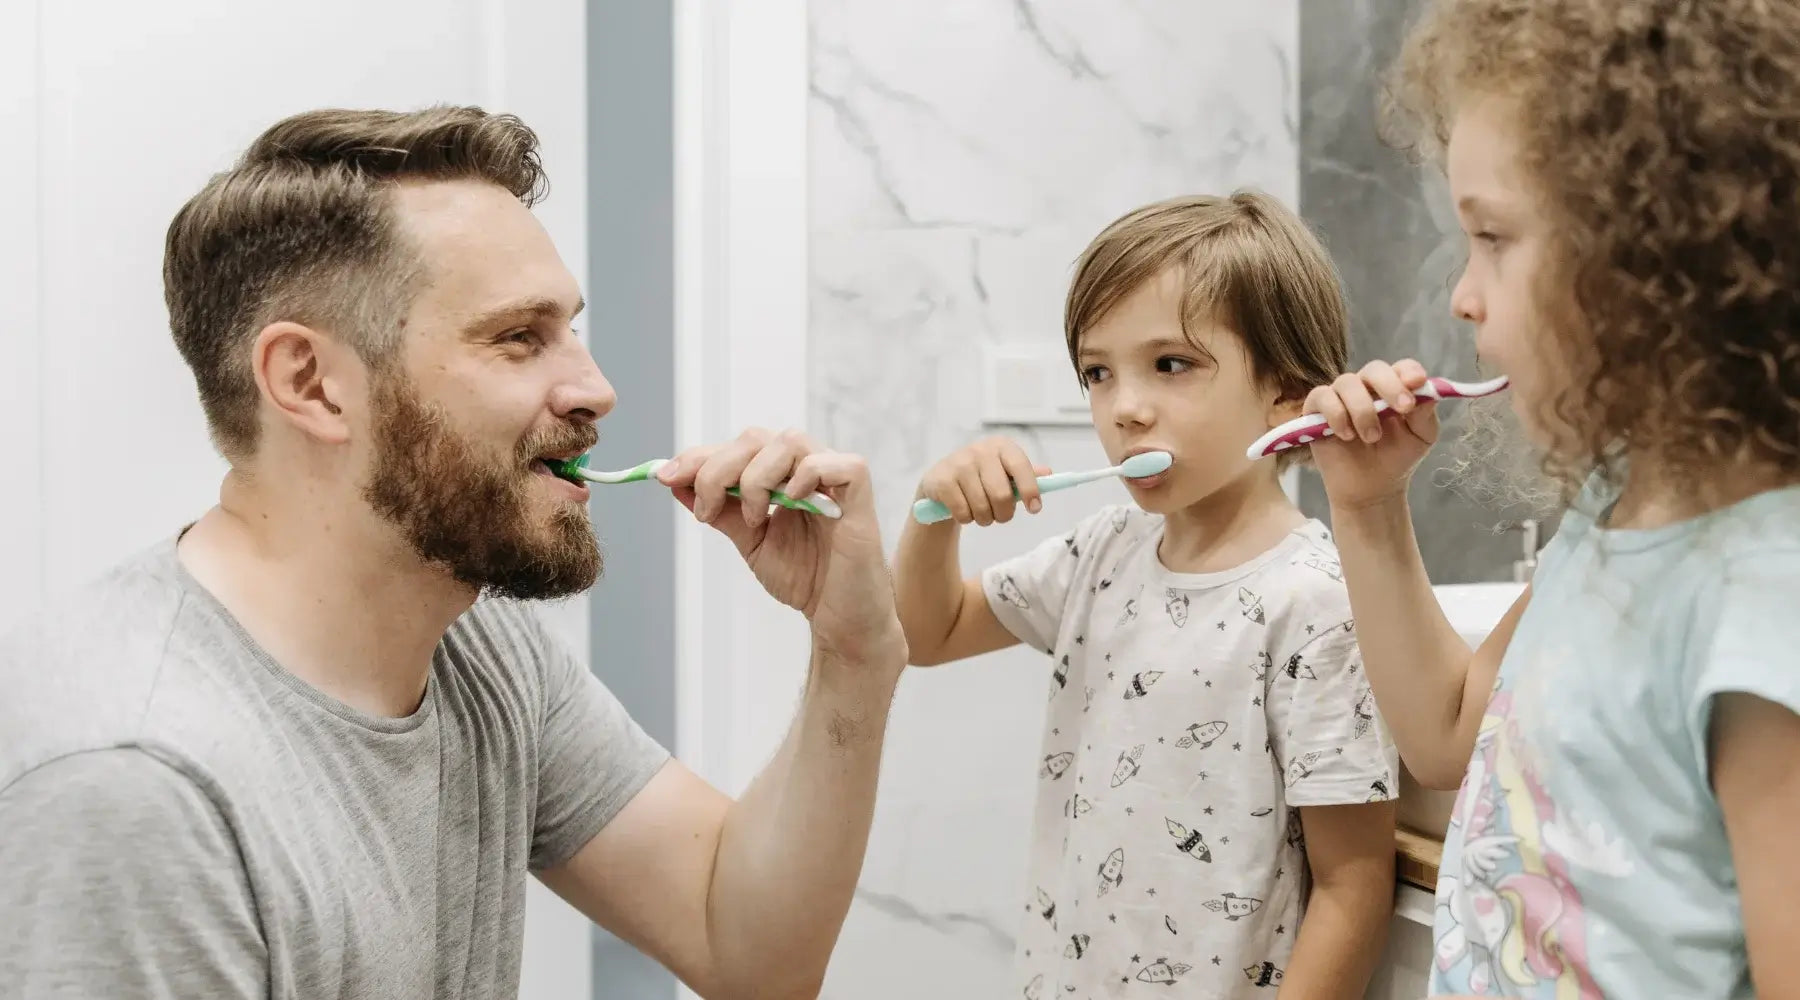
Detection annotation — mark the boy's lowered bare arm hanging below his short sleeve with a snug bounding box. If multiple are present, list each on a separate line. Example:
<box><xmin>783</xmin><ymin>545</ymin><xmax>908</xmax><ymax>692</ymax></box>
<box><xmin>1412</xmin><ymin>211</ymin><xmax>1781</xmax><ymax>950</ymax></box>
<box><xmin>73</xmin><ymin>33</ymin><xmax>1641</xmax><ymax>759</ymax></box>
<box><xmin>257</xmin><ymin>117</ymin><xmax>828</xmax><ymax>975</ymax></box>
<box><xmin>1278</xmin><ymin>800</ymin><xmax>1395</xmax><ymax>1000</ymax></box>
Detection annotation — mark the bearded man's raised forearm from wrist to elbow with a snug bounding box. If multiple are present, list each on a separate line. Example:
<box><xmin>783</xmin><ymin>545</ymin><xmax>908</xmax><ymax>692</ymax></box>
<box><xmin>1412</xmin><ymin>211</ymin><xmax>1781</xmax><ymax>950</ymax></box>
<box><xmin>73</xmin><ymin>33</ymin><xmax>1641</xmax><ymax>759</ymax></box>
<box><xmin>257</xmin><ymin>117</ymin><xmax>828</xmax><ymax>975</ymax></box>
<box><xmin>707</xmin><ymin>644</ymin><xmax>905</xmax><ymax>998</ymax></box>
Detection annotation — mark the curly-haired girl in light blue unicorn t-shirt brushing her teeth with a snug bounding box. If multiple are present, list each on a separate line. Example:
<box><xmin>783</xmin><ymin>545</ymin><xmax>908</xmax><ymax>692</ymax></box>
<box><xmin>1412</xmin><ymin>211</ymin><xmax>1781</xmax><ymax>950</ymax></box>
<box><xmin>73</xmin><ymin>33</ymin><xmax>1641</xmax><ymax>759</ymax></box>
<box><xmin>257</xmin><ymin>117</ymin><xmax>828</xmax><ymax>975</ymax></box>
<box><xmin>1309</xmin><ymin>0</ymin><xmax>1800</xmax><ymax>998</ymax></box>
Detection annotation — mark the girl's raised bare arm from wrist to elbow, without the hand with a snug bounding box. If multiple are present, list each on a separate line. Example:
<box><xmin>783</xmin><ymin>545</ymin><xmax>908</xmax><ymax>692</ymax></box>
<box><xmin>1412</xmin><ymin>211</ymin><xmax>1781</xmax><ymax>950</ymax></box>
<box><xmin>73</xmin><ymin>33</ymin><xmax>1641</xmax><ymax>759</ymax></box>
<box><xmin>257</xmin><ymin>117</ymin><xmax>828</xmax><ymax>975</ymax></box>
<box><xmin>1332</xmin><ymin>495</ymin><xmax>1532</xmax><ymax>790</ymax></box>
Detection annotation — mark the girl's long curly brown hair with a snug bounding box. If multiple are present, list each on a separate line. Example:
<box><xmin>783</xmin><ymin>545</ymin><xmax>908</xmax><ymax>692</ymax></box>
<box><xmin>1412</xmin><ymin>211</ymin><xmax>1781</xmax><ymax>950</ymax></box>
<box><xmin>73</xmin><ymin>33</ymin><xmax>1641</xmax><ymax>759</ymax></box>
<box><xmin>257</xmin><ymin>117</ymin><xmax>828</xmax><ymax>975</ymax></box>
<box><xmin>1382</xmin><ymin>0</ymin><xmax>1800</xmax><ymax>496</ymax></box>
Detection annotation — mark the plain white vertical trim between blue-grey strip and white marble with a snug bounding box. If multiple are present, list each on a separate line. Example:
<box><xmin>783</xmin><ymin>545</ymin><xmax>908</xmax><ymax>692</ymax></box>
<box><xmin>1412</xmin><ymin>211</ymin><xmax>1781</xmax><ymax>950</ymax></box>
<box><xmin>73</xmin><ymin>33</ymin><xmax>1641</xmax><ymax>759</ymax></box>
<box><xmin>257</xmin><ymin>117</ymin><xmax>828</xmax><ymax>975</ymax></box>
<box><xmin>675</xmin><ymin>0</ymin><xmax>808</xmax><ymax>812</ymax></box>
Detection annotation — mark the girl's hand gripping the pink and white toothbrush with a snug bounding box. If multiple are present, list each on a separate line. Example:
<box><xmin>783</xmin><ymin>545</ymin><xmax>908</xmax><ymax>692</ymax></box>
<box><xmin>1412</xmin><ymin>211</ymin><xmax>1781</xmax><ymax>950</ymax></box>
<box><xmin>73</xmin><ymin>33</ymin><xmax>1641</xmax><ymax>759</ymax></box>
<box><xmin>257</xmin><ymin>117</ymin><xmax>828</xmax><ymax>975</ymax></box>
<box><xmin>1307</xmin><ymin>358</ymin><xmax>1438</xmax><ymax>511</ymax></box>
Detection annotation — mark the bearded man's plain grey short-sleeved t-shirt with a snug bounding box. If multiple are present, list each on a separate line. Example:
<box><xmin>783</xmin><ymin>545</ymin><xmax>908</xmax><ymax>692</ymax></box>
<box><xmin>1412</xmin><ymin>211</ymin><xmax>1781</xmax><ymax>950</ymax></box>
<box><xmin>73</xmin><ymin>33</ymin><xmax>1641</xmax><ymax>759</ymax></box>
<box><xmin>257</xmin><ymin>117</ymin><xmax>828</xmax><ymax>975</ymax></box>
<box><xmin>0</xmin><ymin>540</ymin><xmax>668</xmax><ymax>1000</ymax></box>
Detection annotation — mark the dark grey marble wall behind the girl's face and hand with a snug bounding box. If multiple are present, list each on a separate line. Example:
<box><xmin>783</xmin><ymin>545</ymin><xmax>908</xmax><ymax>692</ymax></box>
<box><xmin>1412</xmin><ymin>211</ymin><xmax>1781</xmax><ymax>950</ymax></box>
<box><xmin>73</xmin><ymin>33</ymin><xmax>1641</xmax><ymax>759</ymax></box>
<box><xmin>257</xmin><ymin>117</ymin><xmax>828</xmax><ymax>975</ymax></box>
<box><xmin>1300</xmin><ymin>0</ymin><xmax>1553</xmax><ymax>583</ymax></box>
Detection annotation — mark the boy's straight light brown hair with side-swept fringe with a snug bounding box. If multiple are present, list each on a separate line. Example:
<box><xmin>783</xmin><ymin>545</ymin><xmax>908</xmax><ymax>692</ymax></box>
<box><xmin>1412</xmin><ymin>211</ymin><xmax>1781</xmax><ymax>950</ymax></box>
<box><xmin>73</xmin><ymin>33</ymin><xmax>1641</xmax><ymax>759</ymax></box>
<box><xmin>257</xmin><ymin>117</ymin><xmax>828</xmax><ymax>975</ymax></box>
<box><xmin>1062</xmin><ymin>189</ymin><xmax>1350</xmax><ymax>468</ymax></box>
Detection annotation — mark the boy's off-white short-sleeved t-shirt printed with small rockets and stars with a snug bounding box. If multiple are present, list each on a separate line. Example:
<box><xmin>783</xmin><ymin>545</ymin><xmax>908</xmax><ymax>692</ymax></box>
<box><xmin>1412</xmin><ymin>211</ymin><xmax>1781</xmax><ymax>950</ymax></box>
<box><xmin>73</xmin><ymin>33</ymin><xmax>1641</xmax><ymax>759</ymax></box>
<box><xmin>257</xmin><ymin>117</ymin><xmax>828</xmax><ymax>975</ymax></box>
<box><xmin>983</xmin><ymin>507</ymin><xmax>1399</xmax><ymax>1000</ymax></box>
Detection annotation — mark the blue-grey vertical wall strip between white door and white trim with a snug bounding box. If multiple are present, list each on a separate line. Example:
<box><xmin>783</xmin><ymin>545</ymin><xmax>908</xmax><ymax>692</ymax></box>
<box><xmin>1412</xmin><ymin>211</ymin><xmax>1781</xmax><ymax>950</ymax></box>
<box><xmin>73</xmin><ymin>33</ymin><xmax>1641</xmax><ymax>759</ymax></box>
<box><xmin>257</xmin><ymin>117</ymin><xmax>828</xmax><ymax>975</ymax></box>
<box><xmin>586</xmin><ymin>0</ymin><xmax>677</xmax><ymax>1000</ymax></box>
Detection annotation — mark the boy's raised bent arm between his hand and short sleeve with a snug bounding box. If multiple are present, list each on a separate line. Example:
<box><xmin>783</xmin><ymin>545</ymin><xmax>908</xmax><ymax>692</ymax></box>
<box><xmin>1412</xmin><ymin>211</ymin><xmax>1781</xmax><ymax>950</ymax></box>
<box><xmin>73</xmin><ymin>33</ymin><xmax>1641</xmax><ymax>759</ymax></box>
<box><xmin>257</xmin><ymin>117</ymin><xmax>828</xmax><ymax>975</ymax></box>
<box><xmin>895</xmin><ymin>518</ymin><xmax>1019</xmax><ymax>667</ymax></box>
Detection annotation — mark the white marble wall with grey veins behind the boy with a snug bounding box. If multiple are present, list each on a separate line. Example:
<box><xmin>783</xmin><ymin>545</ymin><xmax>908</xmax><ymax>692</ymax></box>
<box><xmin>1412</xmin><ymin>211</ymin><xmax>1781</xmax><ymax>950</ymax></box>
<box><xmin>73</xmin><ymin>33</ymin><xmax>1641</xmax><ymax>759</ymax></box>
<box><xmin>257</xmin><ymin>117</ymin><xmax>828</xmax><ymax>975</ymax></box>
<box><xmin>808</xmin><ymin>0</ymin><xmax>1300</xmax><ymax>1000</ymax></box>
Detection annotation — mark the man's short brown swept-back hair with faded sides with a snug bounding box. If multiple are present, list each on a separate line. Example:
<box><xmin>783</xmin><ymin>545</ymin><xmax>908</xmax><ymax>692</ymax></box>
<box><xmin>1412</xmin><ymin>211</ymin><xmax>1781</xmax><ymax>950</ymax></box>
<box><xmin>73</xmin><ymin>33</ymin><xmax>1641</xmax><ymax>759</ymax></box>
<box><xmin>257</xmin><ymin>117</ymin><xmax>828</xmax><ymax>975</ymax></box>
<box><xmin>162</xmin><ymin>108</ymin><xmax>545</xmax><ymax>460</ymax></box>
